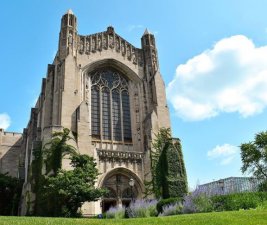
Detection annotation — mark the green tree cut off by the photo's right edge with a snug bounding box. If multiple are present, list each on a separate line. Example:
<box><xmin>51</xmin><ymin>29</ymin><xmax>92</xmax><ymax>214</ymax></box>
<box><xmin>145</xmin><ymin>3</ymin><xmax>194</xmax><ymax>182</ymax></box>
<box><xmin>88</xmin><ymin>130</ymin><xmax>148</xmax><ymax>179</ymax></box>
<box><xmin>240</xmin><ymin>131</ymin><xmax>267</xmax><ymax>181</ymax></box>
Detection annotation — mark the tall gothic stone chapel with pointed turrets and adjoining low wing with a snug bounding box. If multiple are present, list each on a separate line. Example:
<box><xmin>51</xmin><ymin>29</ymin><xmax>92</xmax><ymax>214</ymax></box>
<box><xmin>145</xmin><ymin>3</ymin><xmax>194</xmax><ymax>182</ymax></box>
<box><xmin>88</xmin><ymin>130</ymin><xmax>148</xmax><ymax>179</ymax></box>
<box><xmin>0</xmin><ymin>10</ymin><xmax>174</xmax><ymax>215</ymax></box>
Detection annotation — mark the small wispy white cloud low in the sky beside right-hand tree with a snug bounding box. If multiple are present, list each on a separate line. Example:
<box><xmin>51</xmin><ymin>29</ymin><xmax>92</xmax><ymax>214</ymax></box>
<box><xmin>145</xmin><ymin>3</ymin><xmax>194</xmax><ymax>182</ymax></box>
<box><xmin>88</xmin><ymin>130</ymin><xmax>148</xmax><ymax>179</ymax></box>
<box><xmin>207</xmin><ymin>144</ymin><xmax>238</xmax><ymax>165</ymax></box>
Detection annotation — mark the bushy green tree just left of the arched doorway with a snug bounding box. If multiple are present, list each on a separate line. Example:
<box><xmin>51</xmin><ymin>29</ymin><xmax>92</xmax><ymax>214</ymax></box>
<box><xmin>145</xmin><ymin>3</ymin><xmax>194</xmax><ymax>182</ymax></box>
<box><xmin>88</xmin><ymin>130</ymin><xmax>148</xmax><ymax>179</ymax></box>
<box><xmin>45</xmin><ymin>154</ymin><xmax>108</xmax><ymax>217</ymax></box>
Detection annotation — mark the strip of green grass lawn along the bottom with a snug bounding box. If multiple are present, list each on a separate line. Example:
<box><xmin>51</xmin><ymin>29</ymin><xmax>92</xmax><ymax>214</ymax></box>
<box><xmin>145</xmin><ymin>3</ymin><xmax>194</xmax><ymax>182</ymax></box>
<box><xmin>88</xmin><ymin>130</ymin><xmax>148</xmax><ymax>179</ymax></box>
<box><xmin>0</xmin><ymin>210</ymin><xmax>267</xmax><ymax>225</ymax></box>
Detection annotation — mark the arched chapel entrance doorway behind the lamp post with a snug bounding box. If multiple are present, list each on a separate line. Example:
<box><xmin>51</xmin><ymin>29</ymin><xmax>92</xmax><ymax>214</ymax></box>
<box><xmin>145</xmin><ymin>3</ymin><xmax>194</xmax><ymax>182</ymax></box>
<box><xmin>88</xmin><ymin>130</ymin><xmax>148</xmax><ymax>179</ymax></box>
<box><xmin>99</xmin><ymin>168</ymin><xmax>144</xmax><ymax>213</ymax></box>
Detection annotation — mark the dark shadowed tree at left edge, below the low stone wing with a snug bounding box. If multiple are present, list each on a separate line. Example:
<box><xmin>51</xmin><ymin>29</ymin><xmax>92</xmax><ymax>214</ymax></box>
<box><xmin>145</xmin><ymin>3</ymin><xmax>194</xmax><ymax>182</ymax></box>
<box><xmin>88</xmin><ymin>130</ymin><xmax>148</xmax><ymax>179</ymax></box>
<box><xmin>0</xmin><ymin>173</ymin><xmax>23</xmax><ymax>216</ymax></box>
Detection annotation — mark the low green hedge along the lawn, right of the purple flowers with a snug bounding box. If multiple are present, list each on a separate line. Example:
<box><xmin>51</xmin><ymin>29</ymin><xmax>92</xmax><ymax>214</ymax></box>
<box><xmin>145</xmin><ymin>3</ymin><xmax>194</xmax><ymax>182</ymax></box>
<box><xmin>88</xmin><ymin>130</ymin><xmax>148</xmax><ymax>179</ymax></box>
<box><xmin>212</xmin><ymin>192</ymin><xmax>267</xmax><ymax>211</ymax></box>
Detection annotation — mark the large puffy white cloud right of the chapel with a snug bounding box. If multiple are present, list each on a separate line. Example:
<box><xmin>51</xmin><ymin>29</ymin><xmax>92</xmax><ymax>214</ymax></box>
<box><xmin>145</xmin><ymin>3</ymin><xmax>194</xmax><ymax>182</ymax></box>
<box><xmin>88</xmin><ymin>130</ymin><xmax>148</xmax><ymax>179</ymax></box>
<box><xmin>167</xmin><ymin>35</ymin><xmax>267</xmax><ymax>121</ymax></box>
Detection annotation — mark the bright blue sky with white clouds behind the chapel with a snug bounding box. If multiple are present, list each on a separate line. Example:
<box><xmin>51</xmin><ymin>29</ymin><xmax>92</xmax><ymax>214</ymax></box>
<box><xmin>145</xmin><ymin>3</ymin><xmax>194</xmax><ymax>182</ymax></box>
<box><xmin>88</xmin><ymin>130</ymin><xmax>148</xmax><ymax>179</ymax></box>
<box><xmin>0</xmin><ymin>0</ymin><xmax>267</xmax><ymax>187</ymax></box>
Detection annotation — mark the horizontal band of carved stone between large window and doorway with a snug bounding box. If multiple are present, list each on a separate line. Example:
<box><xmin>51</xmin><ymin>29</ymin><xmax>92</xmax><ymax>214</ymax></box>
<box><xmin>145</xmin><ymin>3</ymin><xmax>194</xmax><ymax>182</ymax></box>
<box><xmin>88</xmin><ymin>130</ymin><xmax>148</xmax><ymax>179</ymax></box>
<box><xmin>96</xmin><ymin>149</ymin><xmax>144</xmax><ymax>163</ymax></box>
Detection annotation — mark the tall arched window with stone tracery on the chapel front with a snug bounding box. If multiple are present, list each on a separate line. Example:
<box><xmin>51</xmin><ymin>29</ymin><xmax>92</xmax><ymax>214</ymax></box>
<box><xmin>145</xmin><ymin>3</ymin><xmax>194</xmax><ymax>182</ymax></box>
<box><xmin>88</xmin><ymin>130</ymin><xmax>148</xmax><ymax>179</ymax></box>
<box><xmin>89</xmin><ymin>69</ymin><xmax>132</xmax><ymax>142</ymax></box>
